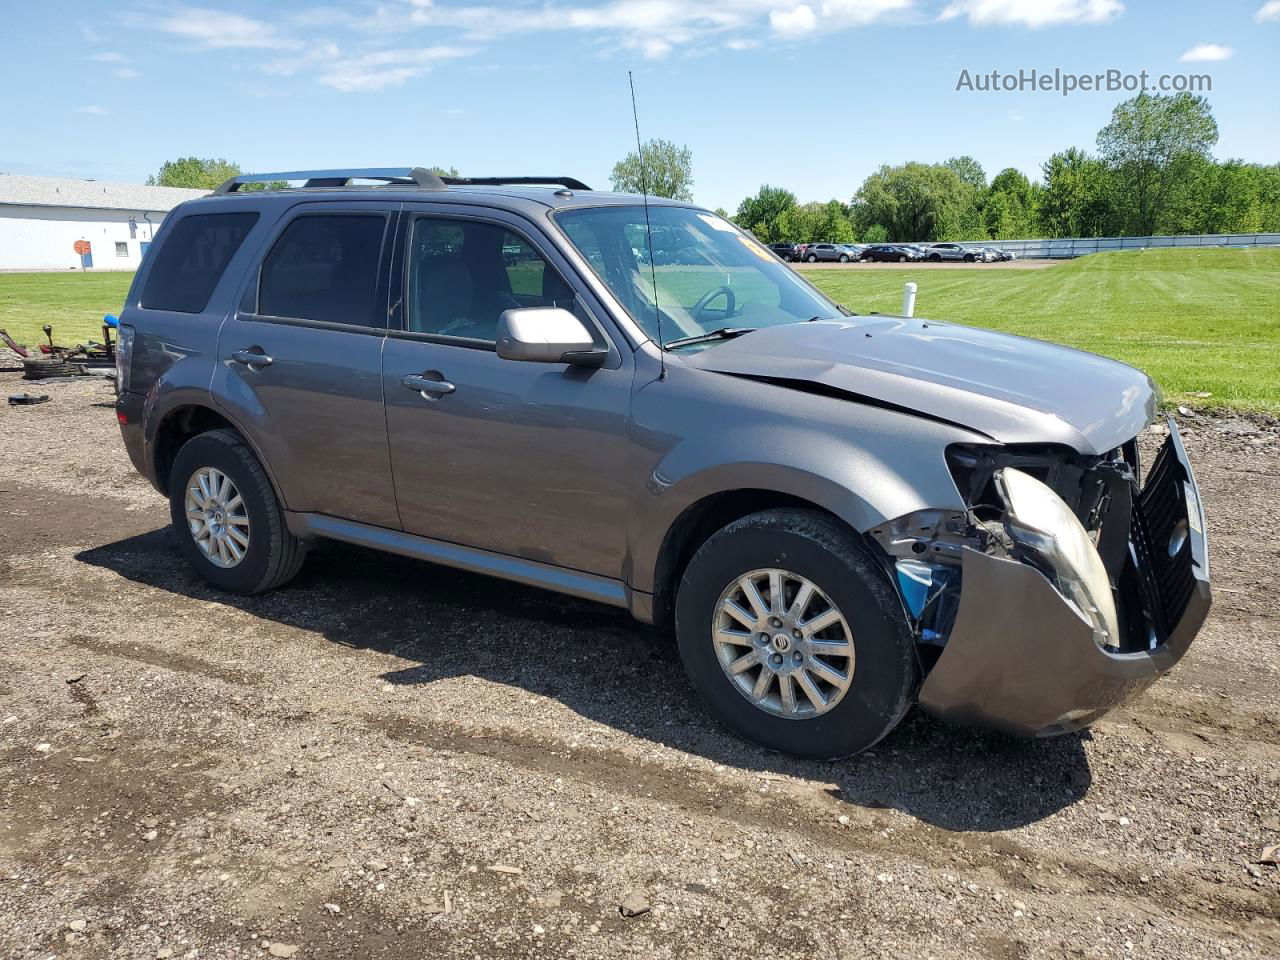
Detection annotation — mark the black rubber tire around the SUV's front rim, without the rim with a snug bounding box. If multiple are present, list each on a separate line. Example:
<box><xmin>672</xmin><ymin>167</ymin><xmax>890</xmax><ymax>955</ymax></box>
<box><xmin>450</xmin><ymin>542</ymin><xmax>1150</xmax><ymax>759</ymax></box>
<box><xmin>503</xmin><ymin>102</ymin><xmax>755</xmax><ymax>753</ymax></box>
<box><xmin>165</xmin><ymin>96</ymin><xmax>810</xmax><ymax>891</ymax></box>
<box><xmin>676</xmin><ymin>509</ymin><xmax>918</xmax><ymax>760</ymax></box>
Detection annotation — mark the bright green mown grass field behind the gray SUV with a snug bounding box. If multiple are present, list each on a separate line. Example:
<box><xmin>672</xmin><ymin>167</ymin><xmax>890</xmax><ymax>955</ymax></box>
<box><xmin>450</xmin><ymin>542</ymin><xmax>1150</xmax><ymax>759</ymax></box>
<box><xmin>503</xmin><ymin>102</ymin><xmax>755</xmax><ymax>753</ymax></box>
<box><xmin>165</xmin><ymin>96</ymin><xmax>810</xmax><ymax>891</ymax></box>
<box><xmin>0</xmin><ymin>250</ymin><xmax>1280</xmax><ymax>413</ymax></box>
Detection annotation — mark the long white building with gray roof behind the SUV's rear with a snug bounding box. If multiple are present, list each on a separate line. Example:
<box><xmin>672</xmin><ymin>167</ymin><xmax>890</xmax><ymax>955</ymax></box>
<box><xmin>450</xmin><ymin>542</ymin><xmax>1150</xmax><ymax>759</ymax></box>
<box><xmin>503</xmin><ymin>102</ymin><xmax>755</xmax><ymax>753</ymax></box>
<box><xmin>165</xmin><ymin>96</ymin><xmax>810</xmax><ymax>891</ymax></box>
<box><xmin>0</xmin><ymin>173</ymin><xmax>209</xmax><ymax>270</ymax></box>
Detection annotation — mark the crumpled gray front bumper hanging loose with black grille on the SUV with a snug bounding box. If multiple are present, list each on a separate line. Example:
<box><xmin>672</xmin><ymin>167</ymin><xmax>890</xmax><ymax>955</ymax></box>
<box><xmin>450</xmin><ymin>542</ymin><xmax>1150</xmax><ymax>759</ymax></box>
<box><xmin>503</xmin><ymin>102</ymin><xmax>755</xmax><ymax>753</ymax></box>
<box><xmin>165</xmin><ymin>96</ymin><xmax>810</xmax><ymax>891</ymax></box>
<box><xmin>919</xmin><ymin>421</ymin><xmax>1211</xmax><ymax>736</ymax></box>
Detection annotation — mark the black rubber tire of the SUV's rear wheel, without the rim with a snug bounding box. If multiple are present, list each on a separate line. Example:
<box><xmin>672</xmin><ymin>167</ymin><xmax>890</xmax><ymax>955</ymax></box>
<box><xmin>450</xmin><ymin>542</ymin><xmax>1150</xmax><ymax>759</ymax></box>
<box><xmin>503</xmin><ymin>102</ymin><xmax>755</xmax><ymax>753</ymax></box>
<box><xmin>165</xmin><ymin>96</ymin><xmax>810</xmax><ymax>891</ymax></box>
<box><xmin>169</xmin><ymin>430</ymin><xmax>306</xmax><ymax>594</ymax></box>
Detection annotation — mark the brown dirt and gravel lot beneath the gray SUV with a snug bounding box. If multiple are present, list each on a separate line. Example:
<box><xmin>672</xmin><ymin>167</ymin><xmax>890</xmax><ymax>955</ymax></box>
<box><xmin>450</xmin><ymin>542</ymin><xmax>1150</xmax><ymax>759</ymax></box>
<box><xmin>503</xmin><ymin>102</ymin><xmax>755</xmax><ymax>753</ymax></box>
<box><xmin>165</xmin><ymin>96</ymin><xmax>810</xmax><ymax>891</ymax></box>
<box><xmin>0</xmin><ymin>374</ymin><xmax>1280</xmax><ymax>960</ymax></box>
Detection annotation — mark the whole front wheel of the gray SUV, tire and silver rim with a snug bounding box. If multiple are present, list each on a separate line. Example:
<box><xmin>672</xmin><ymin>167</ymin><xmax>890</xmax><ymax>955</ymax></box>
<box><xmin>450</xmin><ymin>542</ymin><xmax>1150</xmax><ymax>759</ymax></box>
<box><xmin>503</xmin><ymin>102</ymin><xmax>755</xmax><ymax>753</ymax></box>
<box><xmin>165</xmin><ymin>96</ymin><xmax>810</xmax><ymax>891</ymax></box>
<box><xmin>676</xmin><ymin>509</ymin><xmax>916</xmax><ymax>759</ymax></box>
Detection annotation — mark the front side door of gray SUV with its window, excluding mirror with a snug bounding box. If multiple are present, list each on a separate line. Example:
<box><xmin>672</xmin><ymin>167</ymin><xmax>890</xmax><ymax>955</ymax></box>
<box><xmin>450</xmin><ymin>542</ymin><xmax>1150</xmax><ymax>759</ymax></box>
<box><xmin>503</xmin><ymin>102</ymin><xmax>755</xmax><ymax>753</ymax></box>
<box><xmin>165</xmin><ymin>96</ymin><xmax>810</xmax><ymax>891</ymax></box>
<box><xmin>383</xmin><ymin>205</ymin><xmax>632</xmax><ymax>579</ymax></box>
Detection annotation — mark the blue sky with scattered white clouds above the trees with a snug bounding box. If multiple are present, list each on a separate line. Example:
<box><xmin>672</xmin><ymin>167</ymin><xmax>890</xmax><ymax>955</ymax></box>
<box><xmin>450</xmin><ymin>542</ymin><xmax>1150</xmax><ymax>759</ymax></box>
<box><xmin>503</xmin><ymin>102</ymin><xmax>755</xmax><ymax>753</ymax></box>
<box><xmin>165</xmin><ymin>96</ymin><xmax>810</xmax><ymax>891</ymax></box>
<box><xmin>0</xmin><ymin>0</ymin><xmax>1280</xmax><ymax>211</ymax></box>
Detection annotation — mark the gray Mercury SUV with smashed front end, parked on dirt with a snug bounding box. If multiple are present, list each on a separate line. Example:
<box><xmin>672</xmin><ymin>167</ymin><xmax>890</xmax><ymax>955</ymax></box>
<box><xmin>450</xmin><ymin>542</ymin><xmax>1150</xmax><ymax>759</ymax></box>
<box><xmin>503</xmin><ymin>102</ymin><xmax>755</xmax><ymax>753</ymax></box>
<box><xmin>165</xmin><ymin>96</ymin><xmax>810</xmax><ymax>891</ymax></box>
<box><xmin>116</xmin><ymin>168</ymin><xmax>1210</xmax><ymax>758</ymax></box>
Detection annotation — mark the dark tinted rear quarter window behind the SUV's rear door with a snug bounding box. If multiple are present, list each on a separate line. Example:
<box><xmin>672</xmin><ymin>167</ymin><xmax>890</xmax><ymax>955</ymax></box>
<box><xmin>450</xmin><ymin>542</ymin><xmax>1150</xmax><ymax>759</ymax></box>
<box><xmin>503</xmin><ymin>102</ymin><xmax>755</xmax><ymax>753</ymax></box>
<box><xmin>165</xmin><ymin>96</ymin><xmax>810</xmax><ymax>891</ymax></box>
<box><xmin>142</xmin><ymin>211</ymin><xmax>257</xmax><ymax>314</ymax></box>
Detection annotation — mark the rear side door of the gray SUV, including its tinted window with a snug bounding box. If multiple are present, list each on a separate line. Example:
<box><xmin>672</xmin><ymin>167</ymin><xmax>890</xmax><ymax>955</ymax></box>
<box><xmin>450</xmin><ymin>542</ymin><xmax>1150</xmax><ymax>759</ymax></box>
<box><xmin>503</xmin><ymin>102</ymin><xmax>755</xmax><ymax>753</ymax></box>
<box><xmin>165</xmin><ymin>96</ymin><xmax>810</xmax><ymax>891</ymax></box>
<box><xmin>212</xmin><ymin>200</ymin><xmax>399</xmax><ymax>527</ymax></box>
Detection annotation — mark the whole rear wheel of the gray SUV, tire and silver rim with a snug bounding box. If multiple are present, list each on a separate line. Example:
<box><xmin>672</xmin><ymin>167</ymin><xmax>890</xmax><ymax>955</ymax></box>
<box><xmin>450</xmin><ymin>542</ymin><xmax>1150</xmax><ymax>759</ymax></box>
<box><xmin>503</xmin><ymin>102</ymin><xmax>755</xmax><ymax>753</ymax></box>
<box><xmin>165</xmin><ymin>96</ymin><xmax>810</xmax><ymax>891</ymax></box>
<box><xmin>169</xmin><ymin>430</ymin><xmax>305</xmax><ymax>594</ymax></box>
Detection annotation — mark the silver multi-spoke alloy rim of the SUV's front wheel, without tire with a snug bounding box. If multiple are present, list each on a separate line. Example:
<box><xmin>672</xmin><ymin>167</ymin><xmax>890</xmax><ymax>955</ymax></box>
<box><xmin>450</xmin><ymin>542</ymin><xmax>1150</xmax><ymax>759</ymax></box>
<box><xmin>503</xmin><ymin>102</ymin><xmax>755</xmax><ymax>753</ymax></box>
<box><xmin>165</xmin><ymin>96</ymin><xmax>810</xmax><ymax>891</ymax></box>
<box><xmin>712</xmin><ymin>568</ymin><xmax>854</xmax><ymax>719</ymax></box>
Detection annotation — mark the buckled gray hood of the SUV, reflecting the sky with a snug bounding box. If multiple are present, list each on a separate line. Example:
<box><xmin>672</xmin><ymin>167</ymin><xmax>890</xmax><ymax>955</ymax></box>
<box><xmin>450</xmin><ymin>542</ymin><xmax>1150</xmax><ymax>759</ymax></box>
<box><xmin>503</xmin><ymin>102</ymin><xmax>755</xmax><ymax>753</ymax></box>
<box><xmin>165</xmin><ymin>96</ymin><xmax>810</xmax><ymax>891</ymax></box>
<box><xmin>685</xmin><ymin>316</ymin><xmax>1158</xmax><ymax>454</ymax></box>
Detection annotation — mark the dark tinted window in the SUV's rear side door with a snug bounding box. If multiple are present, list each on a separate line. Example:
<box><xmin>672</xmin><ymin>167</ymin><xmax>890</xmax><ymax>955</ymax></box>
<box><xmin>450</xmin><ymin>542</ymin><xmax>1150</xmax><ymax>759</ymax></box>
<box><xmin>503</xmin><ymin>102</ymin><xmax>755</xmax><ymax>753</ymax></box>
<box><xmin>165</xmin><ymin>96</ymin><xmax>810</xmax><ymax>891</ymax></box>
<box><xmin>257</xmin><ymin>214</ymin><xmax>387</xmax><ymax>326</ymax></box>
